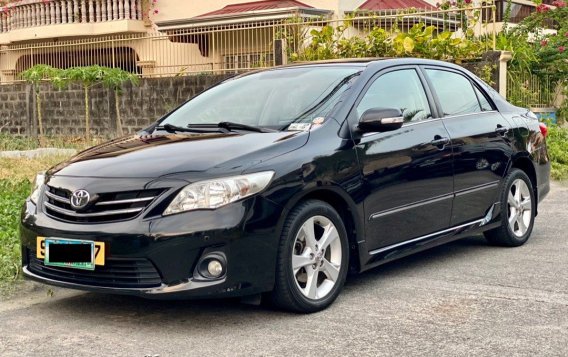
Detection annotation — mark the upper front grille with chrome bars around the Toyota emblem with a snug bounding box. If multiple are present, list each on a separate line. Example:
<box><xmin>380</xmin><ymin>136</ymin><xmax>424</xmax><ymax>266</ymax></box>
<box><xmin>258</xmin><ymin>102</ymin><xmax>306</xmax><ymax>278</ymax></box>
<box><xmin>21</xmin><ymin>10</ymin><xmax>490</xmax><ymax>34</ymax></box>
<box><xmin>43</xmin><ymin>186</ymin><xmax>163</xmax><ymax>223</ymax></box>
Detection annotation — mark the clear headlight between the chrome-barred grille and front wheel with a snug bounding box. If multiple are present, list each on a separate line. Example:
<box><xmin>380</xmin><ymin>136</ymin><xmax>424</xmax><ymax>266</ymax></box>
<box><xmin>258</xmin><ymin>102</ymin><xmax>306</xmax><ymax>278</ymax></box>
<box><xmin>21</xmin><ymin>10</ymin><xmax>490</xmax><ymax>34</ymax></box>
<box><xmin>164</xmin><ymin>171</ymin><xmax>274</xmax><ymax>215</ymax></box>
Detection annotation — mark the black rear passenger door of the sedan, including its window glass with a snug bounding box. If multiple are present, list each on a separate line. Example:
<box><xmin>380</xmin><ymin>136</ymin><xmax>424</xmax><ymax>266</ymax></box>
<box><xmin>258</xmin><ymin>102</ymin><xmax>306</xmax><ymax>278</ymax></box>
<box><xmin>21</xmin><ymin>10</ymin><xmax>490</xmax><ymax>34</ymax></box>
<box><xmin>423</xmin><ymin>67</ymin><xmax>513</xmax><ymax>226</ymax></box>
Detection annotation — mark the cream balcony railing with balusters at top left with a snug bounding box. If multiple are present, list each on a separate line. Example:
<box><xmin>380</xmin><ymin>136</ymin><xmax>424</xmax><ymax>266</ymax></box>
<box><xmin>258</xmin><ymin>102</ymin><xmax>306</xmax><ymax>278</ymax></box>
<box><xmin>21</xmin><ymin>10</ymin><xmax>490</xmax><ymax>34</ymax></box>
<box><xmin>0</xmin><ymin>0</ymin><xmax>144</xmax><ymax>33</ymax></box>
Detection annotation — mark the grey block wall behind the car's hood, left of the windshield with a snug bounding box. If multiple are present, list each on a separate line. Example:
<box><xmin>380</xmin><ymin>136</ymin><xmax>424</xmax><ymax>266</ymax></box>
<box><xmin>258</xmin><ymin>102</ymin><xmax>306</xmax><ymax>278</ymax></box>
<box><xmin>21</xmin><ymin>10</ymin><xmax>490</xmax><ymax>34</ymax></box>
<box><xmin>0</xmin><ymin>75</ymin><xmax>231</xmax><ymax>136</ymax></box>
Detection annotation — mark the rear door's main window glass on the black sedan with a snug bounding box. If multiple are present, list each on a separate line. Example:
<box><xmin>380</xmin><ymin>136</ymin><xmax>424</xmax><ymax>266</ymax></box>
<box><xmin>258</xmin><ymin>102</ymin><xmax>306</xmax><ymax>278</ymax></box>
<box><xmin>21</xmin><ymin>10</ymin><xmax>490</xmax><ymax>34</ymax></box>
<box><xmin>426</xmin><ymin>69</ymin><xmax>481</xmax><ymax>116</ymax></box>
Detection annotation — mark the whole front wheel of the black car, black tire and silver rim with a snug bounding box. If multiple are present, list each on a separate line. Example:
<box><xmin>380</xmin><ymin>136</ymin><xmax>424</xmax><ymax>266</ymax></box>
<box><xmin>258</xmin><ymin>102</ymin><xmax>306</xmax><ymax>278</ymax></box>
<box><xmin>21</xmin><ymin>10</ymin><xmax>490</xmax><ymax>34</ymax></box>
<box><xmin>271</xmin><ymin>200</ymin><xmax>349</xmax><ymax>313</ymax></box>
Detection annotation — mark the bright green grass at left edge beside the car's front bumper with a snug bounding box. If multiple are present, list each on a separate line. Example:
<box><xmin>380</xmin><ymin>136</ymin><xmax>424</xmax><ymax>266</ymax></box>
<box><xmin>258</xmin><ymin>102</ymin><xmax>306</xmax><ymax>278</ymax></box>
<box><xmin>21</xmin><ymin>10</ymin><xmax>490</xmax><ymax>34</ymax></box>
<box><xmin>0</xmin><ymin>179</ymin><xmax>31</xmax><ymax>285</ymax></box>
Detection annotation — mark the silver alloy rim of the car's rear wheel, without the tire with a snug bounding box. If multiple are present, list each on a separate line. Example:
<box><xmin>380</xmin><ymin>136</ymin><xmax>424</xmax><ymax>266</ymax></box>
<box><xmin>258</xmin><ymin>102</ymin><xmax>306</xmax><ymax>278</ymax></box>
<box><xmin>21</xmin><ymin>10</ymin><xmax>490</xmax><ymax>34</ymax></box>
<box><xmin>507</xmin><ymin>179</ymin><xmax>532</xmax><ymax>237</ymax></box>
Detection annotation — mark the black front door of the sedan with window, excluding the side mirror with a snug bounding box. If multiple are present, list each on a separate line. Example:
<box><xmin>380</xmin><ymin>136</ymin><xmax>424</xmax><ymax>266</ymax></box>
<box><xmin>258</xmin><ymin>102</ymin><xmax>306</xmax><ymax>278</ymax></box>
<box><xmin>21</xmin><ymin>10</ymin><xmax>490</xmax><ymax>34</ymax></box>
<box><xmin>353</xmin><ymin>67</ymin><xmax>453</xmax><ymax>251</ymax></box>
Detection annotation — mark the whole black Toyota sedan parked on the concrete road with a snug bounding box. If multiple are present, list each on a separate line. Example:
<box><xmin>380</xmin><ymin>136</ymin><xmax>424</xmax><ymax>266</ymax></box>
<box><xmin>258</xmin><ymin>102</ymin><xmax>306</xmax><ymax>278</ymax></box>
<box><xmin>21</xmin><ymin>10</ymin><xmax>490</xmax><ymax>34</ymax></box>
<box><xmin>21</xmin><ymin>59</ymin><xmax>550</xmax><ymax>312</ymax></box>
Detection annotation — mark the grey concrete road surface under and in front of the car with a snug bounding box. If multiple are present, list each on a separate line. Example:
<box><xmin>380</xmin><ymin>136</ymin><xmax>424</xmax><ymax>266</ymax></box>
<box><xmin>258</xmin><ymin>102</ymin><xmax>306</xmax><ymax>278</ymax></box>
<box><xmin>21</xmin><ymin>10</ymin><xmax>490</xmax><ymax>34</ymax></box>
<box><xmin>0</xmin><ymin>184</ymin><xmax>568</xmax><ymax>357</ymax></box>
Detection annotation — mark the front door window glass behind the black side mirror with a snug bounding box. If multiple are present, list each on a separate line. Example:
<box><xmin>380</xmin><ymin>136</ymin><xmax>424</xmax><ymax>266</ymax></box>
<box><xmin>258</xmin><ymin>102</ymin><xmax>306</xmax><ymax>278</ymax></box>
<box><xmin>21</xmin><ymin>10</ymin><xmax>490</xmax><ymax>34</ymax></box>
<box><xmin>357</xmin><ymin>69</ymin><xmax>432</xmax><ymax>121</ymax></box>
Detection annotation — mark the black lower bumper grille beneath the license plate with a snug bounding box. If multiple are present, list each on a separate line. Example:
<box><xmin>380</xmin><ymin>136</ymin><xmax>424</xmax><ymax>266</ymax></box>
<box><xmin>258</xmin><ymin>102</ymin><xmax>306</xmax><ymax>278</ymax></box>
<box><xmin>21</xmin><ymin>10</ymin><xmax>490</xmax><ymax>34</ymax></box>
<box><xmin>28</xmin><ymin>250</ymin><xmax>162</xmax><ymax>288</ymax></box>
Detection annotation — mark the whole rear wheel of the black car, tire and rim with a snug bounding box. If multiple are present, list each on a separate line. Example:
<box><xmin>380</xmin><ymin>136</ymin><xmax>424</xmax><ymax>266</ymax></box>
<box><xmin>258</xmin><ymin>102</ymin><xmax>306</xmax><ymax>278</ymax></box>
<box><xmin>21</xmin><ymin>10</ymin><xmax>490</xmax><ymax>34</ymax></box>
<box><xmin>485</xmin><ymin>169</ymin><xmax>536</xmax><ymax>247</ymax></box>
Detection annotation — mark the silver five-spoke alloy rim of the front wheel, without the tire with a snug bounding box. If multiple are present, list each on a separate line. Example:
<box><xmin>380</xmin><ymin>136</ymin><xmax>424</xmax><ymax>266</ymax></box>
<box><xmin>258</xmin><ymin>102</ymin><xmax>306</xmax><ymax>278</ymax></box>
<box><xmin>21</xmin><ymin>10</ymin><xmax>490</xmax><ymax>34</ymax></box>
<box><xmin>292</xmin><ymin>216</ymin><xmax>342</xmax><ymax>300</ymax></box>
